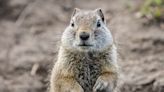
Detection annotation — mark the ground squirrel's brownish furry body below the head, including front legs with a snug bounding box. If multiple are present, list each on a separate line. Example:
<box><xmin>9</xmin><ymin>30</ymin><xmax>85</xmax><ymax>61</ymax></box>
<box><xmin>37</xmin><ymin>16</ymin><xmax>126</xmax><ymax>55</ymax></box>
<box><xmin>50</xmin><ymin>8</ymin><xmax>118</xmax><ymax>92</ymax></box>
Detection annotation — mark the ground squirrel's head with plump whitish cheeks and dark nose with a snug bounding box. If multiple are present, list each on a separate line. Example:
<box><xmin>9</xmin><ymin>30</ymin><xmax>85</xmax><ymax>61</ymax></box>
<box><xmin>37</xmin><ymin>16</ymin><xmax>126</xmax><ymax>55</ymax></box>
<box><xmin>62</xmin><ymin>9</ymin><xmax>113</xmax><ymax>51</ymax></box>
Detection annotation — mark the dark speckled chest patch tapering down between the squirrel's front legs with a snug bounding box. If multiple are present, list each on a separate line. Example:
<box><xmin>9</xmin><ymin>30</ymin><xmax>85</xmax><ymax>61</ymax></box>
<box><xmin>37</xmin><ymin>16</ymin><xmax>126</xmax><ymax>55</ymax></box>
<box><xmin>74</xmin><ymin>59</ymin><xmax>101</xmax><ymax>92</ymax></box>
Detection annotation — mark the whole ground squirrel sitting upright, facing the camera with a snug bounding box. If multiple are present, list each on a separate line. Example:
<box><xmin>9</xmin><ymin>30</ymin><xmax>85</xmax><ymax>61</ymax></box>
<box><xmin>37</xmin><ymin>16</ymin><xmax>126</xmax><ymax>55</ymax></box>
<box><xmin>50</xmin><ymin>8</ymin><xmax>118</xmax><ymax>92</ymax></box>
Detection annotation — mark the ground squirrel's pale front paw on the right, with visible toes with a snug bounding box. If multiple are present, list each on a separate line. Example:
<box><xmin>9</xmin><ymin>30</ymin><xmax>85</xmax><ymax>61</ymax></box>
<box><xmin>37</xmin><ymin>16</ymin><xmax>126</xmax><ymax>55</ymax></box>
<box><xmin>93</xmin><ymin>79</ymin><xmax>112</xmax><ymax>92</ymax></box>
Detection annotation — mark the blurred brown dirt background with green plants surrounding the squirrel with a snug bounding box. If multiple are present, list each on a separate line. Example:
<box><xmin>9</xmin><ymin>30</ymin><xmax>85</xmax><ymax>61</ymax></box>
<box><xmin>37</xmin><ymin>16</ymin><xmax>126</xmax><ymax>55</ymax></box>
<box><xmin>0</xmin><ymin>0</ymin><xmax>164</xmax><ymax>92</ymax></box>
